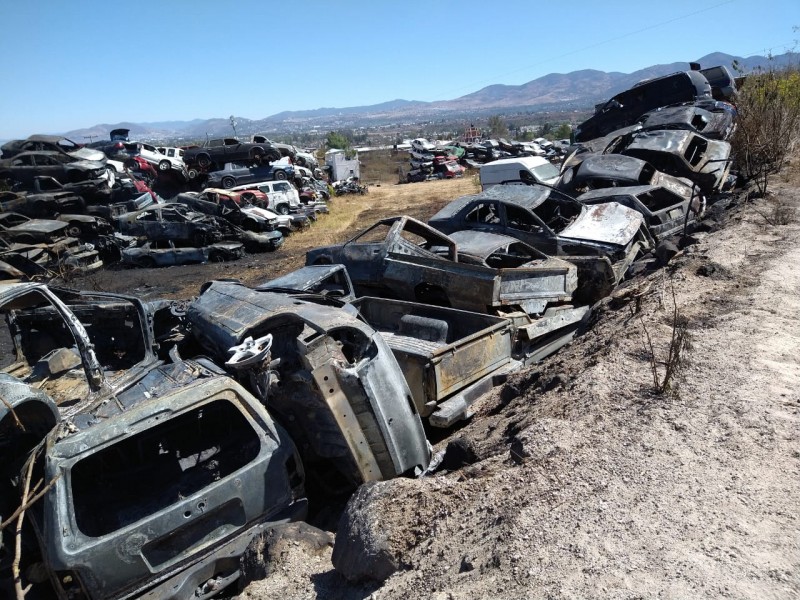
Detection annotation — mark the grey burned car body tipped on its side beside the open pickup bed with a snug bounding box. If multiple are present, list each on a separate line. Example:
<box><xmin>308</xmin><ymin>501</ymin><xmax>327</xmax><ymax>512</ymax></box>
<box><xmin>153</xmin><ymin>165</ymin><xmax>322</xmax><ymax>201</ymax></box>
<box><xmin>187</xmin><ymin>282</ymin><xmax>430</xmax><ymax>482</ymax></box>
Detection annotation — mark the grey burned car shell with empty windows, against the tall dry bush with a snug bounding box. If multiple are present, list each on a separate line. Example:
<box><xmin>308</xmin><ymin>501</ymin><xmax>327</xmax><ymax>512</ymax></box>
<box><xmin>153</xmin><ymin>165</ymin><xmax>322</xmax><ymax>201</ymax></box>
<box><xmin>615</xmin><ymin>129</ymin><xmax>731</xmax><ymax>196</ymax></box>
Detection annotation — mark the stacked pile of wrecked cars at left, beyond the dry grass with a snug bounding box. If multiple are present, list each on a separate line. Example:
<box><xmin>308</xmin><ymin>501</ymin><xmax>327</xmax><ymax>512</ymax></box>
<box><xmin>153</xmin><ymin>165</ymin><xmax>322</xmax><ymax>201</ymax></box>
<box><xmin>0</xmin><ymin>130</ymin><xmax>329</xmax><ymax>280</ymax></box>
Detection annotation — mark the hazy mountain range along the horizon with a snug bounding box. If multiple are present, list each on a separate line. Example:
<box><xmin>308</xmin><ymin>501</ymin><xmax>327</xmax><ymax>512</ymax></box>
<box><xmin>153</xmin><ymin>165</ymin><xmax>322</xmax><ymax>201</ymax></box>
<box><xmin>64</xmin><ymin>52</ymin><xmax>800</xmax><ymax>141</ymax></box>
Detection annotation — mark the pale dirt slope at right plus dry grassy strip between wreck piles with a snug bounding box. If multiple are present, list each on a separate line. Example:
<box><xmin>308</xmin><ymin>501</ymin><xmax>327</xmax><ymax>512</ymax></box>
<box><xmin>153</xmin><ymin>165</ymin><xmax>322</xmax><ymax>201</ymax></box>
<box><xmin>70</xmin><ymin>167</ymin><xmax>800</xmax><ymax>600</ymax></box>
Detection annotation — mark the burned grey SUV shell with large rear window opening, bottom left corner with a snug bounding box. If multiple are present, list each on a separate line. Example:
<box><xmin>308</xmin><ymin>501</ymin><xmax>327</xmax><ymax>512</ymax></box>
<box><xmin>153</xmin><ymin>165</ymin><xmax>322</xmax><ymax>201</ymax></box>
<box><xmin>0</xmin><ymin>284</ymin><xmax>306</xmax><ymax>600</ymax></box>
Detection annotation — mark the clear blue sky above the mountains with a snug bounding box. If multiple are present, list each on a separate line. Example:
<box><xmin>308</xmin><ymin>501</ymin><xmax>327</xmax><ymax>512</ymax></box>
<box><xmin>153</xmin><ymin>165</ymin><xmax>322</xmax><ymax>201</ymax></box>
<box><xmin>0</xmin><ymin>0</ymin><xmax>800</xmax><ymax>139</ymax></box>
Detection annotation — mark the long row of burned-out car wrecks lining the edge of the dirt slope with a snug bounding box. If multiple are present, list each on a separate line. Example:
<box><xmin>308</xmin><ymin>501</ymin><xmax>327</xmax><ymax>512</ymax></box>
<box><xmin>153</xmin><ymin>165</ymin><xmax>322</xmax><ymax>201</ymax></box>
<box><xmin>0</xmin><ymin>62</ymin><xmax>735</xmax><ymax>599</ymax></box>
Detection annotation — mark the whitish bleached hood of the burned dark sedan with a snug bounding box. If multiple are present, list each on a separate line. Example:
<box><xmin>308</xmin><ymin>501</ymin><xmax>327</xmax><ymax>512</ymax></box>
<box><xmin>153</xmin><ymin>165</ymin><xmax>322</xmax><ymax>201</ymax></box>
<box><xmin>560</xmin><ymin>202</ymin><xmax>644</xmax><ymax>246</ymax></box>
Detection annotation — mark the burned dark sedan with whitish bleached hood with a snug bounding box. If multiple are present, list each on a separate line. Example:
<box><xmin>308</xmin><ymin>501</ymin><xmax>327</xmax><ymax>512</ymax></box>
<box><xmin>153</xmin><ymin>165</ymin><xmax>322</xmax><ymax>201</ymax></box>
<box><xmin>428</xmin><ymin>184</ymin><xmax>653</xmax><ymax>303</ymax></box>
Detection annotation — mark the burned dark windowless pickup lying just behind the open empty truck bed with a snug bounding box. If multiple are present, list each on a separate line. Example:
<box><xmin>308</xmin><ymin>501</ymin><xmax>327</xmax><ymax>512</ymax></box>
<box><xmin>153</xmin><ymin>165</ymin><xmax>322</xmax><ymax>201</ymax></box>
<box><xmin>306</xmin><ymin>216</ymin><xmax>577</xmax><ymax>315</ymax></box>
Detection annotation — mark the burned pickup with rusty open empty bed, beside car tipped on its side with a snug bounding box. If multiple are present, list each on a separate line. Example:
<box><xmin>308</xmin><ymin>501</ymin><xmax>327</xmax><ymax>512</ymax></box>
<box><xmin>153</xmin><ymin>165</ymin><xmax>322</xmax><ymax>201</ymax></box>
<box><xmin>256</xmin><ymin>264</ymin><xmax>589</xmax><ymax>427</ymax></box>
